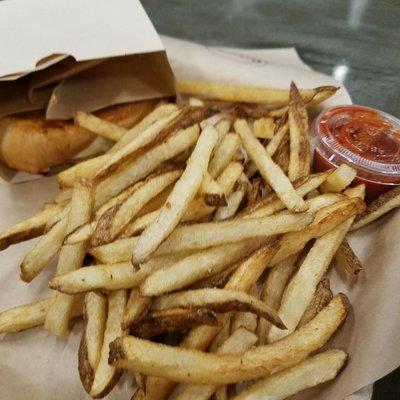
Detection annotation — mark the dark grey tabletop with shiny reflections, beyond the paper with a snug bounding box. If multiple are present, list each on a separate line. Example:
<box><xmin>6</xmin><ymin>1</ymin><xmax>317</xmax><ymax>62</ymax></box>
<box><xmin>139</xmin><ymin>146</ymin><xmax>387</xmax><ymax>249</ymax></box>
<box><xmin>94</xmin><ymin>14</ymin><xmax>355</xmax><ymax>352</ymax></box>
<box><xmin>142</xmin><ymin>0</ymin><xmax>400</xmax><ymax>400</ymax></box>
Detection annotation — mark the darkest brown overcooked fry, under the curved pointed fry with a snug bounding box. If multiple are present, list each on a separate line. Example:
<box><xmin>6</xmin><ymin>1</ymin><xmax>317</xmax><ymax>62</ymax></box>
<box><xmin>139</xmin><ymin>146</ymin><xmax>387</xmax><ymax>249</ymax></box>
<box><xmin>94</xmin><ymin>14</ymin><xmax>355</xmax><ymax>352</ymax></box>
<box><xmin>130</xmin><ymin>308</ymin><xmax>218</xmax><ymax>339</ymax></box>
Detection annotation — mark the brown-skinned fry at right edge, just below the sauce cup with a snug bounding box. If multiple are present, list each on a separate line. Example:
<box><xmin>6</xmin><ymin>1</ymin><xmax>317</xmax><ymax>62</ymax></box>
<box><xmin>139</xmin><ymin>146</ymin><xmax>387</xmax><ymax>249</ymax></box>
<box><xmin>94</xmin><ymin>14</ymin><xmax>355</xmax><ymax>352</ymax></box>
<box><xmin>351</xmin><ymin>186</ymin><xmax>400</xmax><ymax>231</ymax></box>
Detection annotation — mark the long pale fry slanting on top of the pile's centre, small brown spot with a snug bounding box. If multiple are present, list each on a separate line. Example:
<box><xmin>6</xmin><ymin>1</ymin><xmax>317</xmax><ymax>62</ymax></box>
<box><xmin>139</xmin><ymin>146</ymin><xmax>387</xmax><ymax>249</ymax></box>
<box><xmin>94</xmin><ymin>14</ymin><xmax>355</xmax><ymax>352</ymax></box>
<box><xmin>132</xmin><ymin>126</ymin><xmax>218</xmax><ymax>263</ymax></box>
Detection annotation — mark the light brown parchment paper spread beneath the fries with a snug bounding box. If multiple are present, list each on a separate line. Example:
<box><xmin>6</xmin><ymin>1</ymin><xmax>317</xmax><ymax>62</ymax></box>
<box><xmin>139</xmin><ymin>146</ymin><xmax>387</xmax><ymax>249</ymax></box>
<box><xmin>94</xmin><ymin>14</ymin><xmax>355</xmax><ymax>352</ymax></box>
<box><xmin>0</xmin><ymin>39</ymin><xmax>400</xmax><ymax>400</ymax></box>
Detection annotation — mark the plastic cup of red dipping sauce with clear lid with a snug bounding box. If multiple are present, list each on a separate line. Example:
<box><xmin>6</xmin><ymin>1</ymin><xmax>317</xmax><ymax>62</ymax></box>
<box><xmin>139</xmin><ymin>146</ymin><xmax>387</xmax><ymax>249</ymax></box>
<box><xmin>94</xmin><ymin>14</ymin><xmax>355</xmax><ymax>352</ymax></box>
<box><xmin>314</xmin><ymin>106</ymin><xmax>400</xmax><ymax>200</ymax></box>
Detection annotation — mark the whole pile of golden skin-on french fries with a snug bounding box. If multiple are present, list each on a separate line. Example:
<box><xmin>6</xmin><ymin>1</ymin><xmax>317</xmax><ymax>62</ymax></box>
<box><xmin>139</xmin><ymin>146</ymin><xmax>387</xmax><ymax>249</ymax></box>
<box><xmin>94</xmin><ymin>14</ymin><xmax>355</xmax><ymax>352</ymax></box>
<box><xmin>0</xmin><ymin>82</ymin><xmax>400</xmax><ymax>400</ymax></box>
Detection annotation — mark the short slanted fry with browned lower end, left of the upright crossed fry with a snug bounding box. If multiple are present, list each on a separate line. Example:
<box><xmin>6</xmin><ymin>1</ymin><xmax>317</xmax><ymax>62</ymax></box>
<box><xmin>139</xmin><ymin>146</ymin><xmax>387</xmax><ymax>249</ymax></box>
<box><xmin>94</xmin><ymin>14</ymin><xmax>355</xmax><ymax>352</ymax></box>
<box><xmin>20</xmin><ymin>216</ymin><xmax>68</xmax><ymax>282</ymax></box>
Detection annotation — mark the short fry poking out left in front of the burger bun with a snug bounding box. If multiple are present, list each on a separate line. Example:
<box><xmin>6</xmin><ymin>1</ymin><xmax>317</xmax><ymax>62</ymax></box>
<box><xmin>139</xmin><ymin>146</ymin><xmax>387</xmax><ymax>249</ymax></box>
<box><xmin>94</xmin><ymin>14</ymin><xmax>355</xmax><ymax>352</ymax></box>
<box><xmin>74</xmin><ymin>111</ymin><xmax>127</xmax><ymax>142</ymax></box>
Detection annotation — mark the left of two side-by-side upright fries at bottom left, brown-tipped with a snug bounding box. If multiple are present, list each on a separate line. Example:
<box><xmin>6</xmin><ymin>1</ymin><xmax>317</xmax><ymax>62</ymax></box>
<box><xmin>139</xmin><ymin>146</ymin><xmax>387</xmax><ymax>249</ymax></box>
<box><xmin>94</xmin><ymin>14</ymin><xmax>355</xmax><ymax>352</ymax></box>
<box><xmin>78</xmin><ymin>292</ymin><xmax>107</xmax><ymax>393</ymax></box>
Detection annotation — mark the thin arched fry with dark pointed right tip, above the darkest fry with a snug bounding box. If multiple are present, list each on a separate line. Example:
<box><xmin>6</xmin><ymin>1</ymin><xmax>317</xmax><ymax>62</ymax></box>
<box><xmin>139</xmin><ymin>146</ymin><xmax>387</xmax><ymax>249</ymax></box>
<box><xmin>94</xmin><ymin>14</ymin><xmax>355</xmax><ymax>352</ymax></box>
<box><xmin>151</xmin><ymin>288</ymin><xmax>285</xmax><ymax>329</ymax></box>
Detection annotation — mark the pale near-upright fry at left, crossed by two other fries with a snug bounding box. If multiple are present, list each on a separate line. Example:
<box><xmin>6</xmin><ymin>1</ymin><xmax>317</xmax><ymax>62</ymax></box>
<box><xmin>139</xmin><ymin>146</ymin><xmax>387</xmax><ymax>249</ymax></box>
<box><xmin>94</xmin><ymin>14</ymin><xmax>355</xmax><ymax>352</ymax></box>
<box><xmin>44</xmin><ymin>179</ymin><xmax>94</xmax><ymax>336</ymax></box>
